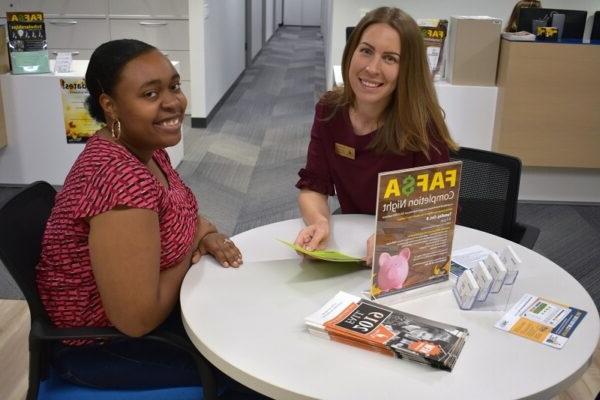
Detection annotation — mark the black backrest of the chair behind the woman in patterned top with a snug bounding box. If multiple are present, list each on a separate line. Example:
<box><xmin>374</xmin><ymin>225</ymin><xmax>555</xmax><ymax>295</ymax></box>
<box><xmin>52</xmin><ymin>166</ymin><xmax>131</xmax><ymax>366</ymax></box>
<box><xmin>0</xmin><ymin>181</ymin><xmax>56</xmax><ymax>320</ymax></box>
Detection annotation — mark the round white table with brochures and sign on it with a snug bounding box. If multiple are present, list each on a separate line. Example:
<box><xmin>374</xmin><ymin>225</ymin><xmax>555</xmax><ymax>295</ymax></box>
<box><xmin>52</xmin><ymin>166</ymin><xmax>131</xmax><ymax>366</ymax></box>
<box><xmin>181</xmin><ymin>215</ymin><xmax>600</xmax><ymax>400</ymax></box>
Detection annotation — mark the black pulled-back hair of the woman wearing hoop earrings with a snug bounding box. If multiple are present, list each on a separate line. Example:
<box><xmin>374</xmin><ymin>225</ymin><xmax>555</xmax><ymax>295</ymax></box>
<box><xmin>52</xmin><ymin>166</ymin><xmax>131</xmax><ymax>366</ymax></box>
<box><xmin>85</xmin><ymin>39</ymin><xmax>156</xmax><ymax>123</ymax></box>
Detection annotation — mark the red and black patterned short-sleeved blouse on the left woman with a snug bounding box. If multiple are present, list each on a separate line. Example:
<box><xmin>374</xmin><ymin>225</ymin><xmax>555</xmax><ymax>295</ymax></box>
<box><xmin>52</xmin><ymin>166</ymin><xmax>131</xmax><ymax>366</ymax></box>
<box><xmin>37</xmin><ymin>135</ymin><xmax>198</xmax><ymax>327</ymax></box>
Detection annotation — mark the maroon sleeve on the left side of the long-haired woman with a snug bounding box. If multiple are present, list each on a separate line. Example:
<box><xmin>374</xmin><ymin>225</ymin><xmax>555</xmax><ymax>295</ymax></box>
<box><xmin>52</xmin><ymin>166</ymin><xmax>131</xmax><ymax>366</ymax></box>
<box><xmin>296</xmin><ymin>103</ymin><xmax>335</xmax><ymax>196</ymax></box>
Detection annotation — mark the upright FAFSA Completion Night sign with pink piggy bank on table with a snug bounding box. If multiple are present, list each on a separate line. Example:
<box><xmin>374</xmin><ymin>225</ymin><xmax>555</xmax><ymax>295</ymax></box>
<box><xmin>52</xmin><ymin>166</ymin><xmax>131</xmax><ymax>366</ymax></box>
<box><xmin>371</xmin><ymin>161</ymin><xmax>462</xmax><ymax>298</ymax></box>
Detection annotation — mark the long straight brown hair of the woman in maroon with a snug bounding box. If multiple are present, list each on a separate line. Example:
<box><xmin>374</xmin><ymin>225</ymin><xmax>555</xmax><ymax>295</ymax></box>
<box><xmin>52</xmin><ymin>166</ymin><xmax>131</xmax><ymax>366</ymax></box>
<box><xmin>321</xmin><ymin>7</ymin><xmax>458</xmax><ymax>157</ymax></box>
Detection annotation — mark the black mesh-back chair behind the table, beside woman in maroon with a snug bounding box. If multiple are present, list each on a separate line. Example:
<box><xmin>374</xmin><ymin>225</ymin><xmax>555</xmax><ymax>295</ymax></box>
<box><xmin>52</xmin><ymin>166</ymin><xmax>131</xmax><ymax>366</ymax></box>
<box><xmin>450</xmin><ymin>147</ymin><xmax>540</xmax><ymax>249</ymax></box>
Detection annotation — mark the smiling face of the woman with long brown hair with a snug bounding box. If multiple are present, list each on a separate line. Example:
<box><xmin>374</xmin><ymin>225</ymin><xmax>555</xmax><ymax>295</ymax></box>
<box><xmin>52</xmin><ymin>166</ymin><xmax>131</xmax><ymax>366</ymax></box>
<box><xmin>348</xmin><ymin>23</ymin><xmax>400</xmax><ymax>109</ymax></box>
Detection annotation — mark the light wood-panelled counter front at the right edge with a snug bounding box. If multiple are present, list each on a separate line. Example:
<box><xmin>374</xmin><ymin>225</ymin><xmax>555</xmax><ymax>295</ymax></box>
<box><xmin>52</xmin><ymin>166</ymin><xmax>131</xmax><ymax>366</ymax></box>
<box><xmin>493</xmin><ymin>40</ymin><xmax>600</xmax><ymax>168</ymax></box>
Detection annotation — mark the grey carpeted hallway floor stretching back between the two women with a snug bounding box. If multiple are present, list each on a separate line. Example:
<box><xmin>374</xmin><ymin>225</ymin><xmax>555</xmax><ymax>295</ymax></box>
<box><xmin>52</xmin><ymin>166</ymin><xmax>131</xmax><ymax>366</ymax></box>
<box><xmin>177</xmin><ymin>27</ymin><xmax>325</xmax><ymax>234</ymax></box>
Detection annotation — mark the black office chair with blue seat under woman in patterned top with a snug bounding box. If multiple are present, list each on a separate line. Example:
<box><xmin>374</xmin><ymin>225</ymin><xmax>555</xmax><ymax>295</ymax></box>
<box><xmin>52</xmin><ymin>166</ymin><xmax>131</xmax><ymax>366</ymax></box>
<box><xmin>0</xmin><ymin>182</ymin><xmax>217</xmax><ymax>400</ymax></box>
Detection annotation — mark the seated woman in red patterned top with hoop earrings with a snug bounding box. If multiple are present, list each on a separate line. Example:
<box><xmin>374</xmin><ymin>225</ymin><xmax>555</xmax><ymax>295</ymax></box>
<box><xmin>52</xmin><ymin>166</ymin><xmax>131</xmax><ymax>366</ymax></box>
<box><xmin>37</xmin><ymin>39</ymin><xmax>242</xmax><ymax>387</ymax></box>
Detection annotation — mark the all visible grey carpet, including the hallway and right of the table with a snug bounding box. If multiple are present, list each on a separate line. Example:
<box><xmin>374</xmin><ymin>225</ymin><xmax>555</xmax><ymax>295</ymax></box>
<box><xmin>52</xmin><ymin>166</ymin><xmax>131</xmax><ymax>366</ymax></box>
<box><xmin>0</xmin><ymin>27</ymin><xmax>600</xmax><ymax>312</ymax></box>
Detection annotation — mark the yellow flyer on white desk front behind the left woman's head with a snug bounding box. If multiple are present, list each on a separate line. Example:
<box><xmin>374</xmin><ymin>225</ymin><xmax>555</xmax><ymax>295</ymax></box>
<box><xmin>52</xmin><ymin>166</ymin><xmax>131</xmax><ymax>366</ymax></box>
<box><xmin>60</xmin><ymin>78</ymin><xmax>102</xmax><ymax>143</ymax></box>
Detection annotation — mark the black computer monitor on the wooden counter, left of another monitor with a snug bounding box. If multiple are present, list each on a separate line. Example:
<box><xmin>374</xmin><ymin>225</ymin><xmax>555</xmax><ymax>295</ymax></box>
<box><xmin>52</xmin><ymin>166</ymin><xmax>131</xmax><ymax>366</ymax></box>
<box><xmin>517</xmin><ymin>8</ymin><xmax>587</xmax><ymax>40</ymax></box>
